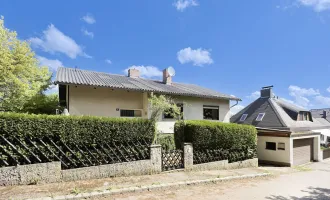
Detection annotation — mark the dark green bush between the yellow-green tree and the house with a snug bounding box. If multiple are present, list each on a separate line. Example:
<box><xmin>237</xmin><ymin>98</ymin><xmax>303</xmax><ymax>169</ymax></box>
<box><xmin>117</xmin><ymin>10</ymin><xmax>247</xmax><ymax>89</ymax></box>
<box><xmin>21</xmin><ymin>94</ymin><xmax>60</xmax><ymax>115</ymax></box>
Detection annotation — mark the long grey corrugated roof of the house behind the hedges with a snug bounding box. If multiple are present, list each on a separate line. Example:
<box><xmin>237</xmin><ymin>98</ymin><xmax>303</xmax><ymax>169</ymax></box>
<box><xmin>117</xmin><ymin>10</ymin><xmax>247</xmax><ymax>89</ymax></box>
<box><xmin>55</xmin><ymin>67</ymin><xmax>240</xmax><ymax>101</ymax></box>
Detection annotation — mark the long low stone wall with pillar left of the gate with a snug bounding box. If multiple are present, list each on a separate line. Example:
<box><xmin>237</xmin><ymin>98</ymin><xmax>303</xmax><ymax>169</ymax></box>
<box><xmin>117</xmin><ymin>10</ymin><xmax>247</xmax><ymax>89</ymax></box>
<box><xmin>0</xmin><ymin>145</ymin><xmax>162</xmax><ymax>186</ymax></box>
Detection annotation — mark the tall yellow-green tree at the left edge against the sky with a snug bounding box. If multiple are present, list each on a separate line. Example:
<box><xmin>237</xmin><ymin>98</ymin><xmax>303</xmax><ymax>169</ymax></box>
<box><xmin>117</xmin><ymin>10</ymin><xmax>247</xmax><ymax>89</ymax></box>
<box><xmin>0</xmin><ymin>17</ymin><xmax>51</xmax><ymax>112</ymax></box>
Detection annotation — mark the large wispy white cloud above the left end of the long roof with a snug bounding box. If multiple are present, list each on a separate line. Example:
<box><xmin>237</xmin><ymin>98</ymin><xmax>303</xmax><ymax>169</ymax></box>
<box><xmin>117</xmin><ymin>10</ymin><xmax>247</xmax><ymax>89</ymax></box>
<box><xmin>30</xmin><ymin>24</ymin><xmax>91</xmax><ymax>59</ymax></box>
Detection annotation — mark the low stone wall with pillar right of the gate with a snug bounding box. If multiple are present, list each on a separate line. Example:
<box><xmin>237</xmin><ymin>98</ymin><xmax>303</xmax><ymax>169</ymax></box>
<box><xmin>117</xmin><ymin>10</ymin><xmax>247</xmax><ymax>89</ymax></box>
<box><xmin>184</xmin><ymin>143</ymin><xmax>258</xmax><ymax>171</ymax></box>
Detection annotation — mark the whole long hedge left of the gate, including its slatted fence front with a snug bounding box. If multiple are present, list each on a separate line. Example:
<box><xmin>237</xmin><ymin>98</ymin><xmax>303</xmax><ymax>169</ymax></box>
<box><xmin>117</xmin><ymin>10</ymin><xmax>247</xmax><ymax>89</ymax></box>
<box><xmin>0</xmin><ymin>113</ymin><xmax>155</xmax><ymax>169</ymax></box>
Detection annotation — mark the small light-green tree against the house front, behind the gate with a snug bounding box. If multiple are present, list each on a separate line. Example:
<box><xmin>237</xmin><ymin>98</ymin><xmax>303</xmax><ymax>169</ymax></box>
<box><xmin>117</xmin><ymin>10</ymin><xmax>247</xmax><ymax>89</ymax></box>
<box><xmin>148</xmin><ymin>94</ymin><xmax>183</xmax><ymax>143</ymax></box>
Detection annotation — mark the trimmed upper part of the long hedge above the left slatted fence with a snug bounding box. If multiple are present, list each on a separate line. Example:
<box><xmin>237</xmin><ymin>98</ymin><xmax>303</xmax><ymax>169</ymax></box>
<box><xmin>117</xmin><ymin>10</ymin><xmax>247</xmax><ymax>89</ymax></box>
<box><xmin>0</xmin><ymin>113</ymin><xmax>155</xmax><ymax>144</ymax></box>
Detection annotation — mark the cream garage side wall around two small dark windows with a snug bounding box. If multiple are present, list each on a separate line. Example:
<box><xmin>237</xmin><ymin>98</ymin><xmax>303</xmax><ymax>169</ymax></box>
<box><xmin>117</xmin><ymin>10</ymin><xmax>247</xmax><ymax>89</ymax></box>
<box><xmin>257</xmin><ymin>136</ymin><xmax>292</xmax><ymax>165</ymax></box>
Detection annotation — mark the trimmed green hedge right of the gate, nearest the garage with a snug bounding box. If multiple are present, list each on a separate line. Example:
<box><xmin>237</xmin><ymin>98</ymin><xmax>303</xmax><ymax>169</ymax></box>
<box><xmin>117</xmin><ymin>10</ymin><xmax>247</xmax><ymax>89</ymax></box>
<box><xmin>175</xmin><ymin>120</ymin><xmax>257</xmax><ymax>161</ymax></box>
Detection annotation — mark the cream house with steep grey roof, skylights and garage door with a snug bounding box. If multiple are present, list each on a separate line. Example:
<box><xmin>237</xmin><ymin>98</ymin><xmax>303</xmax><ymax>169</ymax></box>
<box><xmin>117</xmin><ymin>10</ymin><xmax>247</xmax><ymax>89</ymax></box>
<box><xmin>230</xmin><ymin>86</ymin><xmax>330</xmax><ymax>166</ymax></box>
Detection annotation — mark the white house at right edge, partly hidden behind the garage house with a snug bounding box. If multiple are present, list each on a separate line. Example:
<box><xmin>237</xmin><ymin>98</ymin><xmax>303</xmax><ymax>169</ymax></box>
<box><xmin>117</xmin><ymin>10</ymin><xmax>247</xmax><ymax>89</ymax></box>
<box><xmin>311</xmin><ymin>108</ymin><xmax>330</xmax><ymax>146</ymax></box>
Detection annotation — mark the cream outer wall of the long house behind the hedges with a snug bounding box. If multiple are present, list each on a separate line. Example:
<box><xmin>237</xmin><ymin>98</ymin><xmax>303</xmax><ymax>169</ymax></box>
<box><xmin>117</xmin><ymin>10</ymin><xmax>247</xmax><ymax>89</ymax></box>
<box><xmin>68</xmin><ymin>85</ymin><xmax>230</xmax><ymax>133</ymax></box>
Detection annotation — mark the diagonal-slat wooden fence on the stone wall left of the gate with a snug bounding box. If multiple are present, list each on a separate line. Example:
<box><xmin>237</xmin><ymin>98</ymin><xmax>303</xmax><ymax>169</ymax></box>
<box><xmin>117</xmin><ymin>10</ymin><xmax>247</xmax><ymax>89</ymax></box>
<box><xmin>0</xmin><ymin>135</ymin><xmax>150</xmax><ymax>169</ymax></box>
